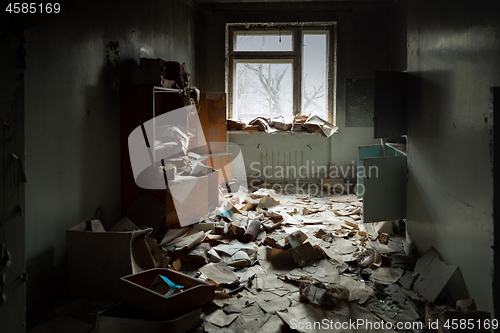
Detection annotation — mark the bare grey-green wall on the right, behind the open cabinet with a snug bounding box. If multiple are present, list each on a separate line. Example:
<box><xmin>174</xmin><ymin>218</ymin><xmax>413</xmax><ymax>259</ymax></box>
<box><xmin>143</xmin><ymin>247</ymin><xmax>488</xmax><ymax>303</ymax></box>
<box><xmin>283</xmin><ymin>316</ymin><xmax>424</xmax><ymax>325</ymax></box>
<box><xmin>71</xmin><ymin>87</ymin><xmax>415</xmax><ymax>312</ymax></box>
<box><xmin>407</xmin><ymin>0</ymin><xmax>500</xmax><ymax>312</ymax></box>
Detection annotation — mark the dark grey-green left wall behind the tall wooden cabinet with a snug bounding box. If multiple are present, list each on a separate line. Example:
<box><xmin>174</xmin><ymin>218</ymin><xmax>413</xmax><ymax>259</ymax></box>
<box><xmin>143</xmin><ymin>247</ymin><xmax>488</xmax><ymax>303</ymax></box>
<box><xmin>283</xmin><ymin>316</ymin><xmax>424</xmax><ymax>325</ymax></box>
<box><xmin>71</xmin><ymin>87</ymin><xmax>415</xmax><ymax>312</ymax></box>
<box><xmin>26</xmin><ymin>0</ymin><xmax>196</xmax><ymax>309</ymax></box>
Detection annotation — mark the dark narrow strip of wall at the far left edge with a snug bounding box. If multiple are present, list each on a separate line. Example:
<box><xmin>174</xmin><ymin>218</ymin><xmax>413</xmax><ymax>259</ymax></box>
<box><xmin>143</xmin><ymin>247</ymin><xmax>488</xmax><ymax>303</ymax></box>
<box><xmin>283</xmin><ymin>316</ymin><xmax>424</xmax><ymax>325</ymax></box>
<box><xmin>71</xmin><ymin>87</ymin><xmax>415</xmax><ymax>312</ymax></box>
<box><xmin>0</xmin><ymin>13</ymin><xmax>26</xmax><ymax>333</ymax></box>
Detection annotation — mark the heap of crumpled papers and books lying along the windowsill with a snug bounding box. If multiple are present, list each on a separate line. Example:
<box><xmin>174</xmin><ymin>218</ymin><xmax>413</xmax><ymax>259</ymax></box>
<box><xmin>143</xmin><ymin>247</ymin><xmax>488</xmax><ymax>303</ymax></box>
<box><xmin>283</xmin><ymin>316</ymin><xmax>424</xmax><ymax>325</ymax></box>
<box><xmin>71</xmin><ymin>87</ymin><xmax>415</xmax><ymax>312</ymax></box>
<box><xmin>227</xmin><ymin>114</ymin><xmax>338</xmax><ymax>137</ymax></box>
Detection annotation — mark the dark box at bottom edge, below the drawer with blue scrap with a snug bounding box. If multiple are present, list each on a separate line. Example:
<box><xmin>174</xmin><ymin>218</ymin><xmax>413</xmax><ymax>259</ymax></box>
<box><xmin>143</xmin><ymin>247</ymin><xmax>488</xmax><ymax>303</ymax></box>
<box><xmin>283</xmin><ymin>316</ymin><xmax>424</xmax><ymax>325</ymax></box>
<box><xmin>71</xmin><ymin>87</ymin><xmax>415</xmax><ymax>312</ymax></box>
<box><xmin>95</xmin><ymin>303</ymin><xmax>201</xmax><ymax>333</ymax></box>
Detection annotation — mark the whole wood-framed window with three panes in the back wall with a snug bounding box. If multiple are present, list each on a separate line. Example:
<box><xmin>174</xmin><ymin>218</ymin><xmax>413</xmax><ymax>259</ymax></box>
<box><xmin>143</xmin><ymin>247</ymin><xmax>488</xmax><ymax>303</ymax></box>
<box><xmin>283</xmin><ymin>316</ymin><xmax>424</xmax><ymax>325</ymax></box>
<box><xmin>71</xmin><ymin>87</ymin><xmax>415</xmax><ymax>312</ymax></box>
<box><xmin>226</xmin><ymin>22</ymin><xmax>335</xmax><ymax>123</ymax></box>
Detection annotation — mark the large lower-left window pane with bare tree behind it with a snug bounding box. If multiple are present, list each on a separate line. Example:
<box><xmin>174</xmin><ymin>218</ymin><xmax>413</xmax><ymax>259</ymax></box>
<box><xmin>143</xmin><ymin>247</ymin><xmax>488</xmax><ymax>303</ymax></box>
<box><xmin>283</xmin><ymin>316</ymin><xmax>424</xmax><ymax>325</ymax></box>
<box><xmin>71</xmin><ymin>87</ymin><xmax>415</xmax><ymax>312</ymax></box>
<box><xmin>233</xmin><ymin>60</ymin><xmax>293</xmax><ymax>122</ymax></box>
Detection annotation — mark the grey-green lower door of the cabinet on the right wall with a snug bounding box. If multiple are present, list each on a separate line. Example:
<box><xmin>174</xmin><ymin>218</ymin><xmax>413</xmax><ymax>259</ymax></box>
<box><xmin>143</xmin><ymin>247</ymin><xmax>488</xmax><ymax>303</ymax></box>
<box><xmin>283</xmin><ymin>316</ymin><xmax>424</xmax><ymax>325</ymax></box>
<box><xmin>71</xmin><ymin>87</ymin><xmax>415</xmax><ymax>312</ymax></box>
<box><xmin>360</xmin><ymin>156</ymin><xmax>407</xmax><ymax>222</ymax></box>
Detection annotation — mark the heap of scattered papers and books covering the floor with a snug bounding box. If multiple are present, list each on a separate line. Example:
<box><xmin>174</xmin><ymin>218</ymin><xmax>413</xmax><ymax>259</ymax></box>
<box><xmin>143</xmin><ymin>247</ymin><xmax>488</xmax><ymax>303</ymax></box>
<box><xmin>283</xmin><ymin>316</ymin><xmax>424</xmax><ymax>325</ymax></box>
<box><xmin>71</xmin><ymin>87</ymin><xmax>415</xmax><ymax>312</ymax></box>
<box><xmin>61</xmin><ymin>183</ymin><xmax>489</xmax><ymax>332</ymax></box>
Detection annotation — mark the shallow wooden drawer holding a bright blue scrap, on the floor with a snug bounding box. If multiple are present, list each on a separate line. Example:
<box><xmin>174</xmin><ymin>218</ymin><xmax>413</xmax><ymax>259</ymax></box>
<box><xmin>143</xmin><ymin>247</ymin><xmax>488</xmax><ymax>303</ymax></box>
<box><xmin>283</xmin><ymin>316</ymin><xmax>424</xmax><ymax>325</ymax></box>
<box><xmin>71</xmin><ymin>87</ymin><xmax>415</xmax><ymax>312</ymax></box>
<box><xmin>119</xmin><ymin>268</ymin><xmax>215</xmax><ymax>320</ymax></box>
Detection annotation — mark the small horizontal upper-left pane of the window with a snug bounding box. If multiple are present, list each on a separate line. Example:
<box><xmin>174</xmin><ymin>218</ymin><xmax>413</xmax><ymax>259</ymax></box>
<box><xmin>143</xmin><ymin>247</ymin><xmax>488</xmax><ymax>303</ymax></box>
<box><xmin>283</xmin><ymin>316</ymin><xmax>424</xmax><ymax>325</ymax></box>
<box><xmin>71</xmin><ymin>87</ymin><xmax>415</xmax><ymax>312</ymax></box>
<box><xmin>234</xmin><ymin>31</ymin><xmax>293</xmax><ymax>52</ymax></box>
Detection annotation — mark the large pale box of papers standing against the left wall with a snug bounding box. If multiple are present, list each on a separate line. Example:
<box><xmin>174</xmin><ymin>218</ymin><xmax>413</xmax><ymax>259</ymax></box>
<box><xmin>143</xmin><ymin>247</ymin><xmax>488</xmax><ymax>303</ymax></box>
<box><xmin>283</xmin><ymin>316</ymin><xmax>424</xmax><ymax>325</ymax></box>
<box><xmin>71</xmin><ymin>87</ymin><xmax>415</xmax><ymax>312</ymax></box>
<box><xmin>66</xmin><ymin>220</ymin><xmax>155</xmax><ymax>298</ymax></box>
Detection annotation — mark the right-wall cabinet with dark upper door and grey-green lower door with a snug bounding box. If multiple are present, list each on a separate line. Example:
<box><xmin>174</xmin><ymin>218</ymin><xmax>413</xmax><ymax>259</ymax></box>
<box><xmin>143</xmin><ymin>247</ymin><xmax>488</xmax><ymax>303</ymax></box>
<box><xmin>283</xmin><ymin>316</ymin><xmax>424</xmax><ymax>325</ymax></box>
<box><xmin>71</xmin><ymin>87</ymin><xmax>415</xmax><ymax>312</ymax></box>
<box><xmin>358</xmin><ymin>71</ymin><xmax>409</xmax><ymax>222</ymax></box>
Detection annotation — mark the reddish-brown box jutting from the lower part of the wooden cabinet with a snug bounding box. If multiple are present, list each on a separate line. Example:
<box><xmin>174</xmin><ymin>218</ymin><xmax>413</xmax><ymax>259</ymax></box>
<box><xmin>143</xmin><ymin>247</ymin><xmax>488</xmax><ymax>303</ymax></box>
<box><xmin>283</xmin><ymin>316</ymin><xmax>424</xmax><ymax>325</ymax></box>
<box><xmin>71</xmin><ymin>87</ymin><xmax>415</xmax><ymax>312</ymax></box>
<box><xmin>166</xmin><ymin>170</ymin><xmax>219</xmax><ymax>226</ymax></box>
